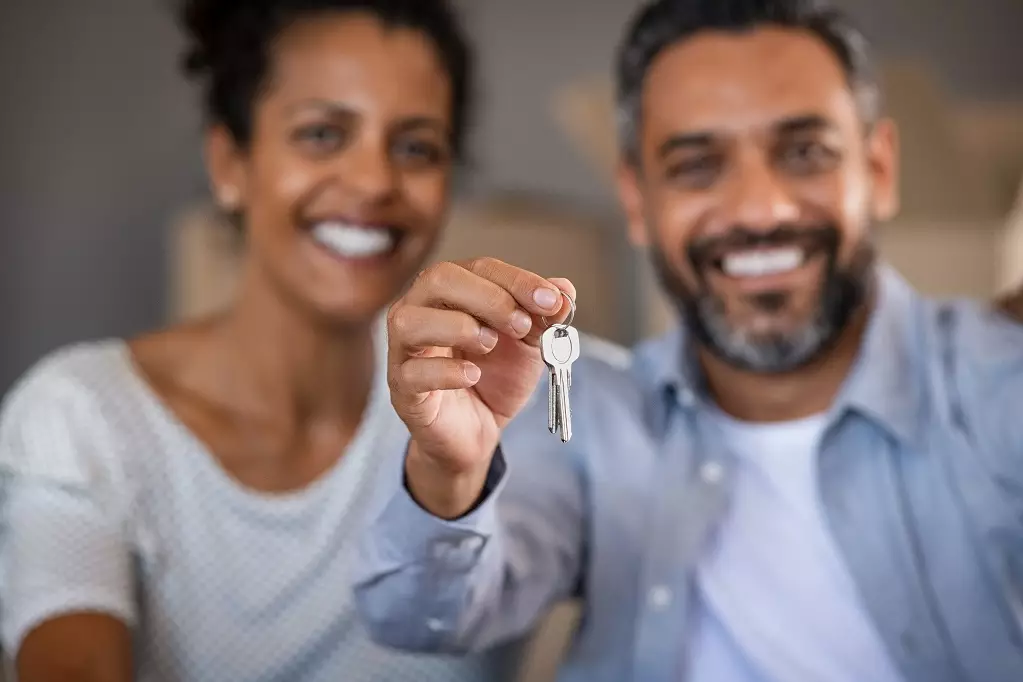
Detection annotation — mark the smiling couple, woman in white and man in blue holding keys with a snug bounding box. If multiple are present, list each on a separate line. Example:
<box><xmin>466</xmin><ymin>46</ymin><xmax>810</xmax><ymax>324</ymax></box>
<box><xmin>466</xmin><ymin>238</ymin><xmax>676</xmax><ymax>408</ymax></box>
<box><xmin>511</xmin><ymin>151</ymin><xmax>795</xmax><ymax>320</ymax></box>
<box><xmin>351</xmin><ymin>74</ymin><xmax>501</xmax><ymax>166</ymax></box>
<box><xmin>0</xmin><ymin>0</ymin><xmax>1023</xmax><ymax>682</ymax></box>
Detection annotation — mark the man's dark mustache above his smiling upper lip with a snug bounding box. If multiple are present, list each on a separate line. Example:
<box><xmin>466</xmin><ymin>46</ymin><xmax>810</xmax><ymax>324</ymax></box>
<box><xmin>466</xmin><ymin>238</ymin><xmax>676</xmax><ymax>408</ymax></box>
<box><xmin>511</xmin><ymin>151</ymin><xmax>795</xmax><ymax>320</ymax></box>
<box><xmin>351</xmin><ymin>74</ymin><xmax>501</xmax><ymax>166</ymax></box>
<box><xmin>686</xmin><ymin>223</ymin><xmax>841</xmax><ymax>270</ymax></box>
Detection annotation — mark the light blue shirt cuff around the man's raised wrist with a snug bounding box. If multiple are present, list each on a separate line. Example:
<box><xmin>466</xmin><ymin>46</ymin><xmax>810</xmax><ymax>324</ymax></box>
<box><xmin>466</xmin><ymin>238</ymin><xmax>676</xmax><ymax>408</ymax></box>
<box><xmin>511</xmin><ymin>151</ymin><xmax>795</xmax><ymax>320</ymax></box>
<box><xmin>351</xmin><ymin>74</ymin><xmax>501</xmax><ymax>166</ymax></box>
<box><xmin>370</xmin><ymin>446</ymin><xmax>507</xmax><ymax>573</ymax></box>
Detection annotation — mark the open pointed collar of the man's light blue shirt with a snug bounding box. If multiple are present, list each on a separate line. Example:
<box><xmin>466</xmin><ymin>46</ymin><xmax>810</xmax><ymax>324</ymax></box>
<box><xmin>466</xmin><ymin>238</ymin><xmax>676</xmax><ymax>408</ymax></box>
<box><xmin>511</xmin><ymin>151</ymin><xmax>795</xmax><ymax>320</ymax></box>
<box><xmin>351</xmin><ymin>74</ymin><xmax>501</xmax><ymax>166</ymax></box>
<box><xmin>636</xmin><ymin>265</ymin><xmax>923</xmax><ymax>443</ymax></box>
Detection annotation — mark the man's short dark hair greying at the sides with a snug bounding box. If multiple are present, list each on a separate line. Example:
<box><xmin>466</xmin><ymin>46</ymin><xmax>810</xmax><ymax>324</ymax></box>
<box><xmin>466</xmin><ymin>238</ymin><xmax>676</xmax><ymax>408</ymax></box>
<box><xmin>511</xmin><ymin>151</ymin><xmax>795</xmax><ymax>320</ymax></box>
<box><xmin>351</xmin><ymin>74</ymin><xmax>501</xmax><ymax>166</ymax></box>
<box><xmin>616</xmin><ymin>0</ymin><xmax>881</xmax><ymax>164</ymax></box>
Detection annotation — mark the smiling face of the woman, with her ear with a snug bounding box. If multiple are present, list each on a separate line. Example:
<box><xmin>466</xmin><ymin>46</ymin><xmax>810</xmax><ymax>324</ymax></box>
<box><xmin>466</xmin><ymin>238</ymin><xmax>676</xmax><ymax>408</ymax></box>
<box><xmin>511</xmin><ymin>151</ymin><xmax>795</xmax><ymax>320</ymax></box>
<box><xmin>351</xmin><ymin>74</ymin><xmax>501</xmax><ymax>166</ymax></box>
<box><xmin>209</xmin><ymin>13</ymin><xmax>452</xmax><ymax>325</ymax></box>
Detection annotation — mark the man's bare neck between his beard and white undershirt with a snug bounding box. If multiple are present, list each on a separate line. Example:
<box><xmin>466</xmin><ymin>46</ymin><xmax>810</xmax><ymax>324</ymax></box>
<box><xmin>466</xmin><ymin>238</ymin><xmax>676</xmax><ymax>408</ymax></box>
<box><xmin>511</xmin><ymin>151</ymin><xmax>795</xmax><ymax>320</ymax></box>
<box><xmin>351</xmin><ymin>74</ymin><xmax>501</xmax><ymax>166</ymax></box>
<box><xmin>699</xmin><ymin>306</ymin><xmax>870</xmax><ymax>422</ymax></box>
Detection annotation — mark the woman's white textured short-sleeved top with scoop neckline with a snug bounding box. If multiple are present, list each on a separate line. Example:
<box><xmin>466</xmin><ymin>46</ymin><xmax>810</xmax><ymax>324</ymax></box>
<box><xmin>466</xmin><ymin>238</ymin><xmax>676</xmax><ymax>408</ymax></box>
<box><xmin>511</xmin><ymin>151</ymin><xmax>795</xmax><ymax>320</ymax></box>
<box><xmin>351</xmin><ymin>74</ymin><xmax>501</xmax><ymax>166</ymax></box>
<box><xmin>0</xmin><ymin>340</ymin><xmax>515</xmax><ymax>682</ymax></box>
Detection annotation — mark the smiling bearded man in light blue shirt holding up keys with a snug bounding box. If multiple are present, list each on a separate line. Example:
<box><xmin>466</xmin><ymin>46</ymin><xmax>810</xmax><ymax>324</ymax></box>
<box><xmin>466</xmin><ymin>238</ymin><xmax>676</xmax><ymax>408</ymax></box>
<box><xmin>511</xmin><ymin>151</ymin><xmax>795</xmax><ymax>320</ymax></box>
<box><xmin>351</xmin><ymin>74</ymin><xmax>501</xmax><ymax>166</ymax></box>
<box><xmin>357</xmin><ymin>0</ymin><xmax>1023</xmax><ymax>682</ymax></box>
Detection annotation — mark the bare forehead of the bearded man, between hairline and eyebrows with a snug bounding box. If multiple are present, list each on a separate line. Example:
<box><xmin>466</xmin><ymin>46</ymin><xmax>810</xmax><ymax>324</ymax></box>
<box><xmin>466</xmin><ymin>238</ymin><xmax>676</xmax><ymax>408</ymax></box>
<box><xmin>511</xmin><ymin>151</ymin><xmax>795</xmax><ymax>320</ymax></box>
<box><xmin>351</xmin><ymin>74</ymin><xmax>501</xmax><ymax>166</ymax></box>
<box><xmin>642</xmin><ymin>28</ymin><xmax>857</xmax><ymax>134</ymax></box>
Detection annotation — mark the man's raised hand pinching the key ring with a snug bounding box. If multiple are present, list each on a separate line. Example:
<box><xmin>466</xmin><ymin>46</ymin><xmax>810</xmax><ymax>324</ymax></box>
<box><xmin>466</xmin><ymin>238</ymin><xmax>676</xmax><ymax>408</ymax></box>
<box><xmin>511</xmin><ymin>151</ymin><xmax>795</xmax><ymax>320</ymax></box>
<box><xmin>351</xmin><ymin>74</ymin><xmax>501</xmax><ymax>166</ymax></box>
<box><xmin>388</xmin><ymin>259</ymin><xmax>575</xmax><ymax>518</ymax></box>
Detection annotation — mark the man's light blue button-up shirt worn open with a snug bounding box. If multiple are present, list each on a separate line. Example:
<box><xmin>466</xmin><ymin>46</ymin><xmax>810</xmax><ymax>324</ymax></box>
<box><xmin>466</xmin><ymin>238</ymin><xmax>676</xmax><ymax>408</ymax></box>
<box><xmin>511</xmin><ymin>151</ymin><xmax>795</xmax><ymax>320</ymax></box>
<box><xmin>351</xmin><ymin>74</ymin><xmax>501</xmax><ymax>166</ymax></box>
<box><xmin>356</xmin><ymin>269</ymin><xmax>1023</xmax><ymax>682</ymax></box>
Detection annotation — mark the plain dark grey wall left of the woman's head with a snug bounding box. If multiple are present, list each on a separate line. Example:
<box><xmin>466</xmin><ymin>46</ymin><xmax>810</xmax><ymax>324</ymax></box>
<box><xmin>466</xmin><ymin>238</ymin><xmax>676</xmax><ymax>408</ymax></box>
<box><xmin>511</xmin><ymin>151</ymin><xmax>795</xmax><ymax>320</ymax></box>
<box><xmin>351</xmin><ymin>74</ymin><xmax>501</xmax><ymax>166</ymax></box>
<box><xmin>0</xmin><ymin>0</ymin><xmax>203</xmax><ymax>390</ymax></box>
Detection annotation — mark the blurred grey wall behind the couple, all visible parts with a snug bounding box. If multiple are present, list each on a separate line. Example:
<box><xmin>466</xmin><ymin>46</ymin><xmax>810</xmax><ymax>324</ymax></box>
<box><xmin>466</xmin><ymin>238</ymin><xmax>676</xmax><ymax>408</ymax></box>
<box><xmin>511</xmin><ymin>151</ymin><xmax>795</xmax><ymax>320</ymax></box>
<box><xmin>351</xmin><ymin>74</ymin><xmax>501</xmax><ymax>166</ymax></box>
<box><xmin>0</xmin><ymin>0</ymin><xmax>1023</xmax><ymax>391</ymax></box>
